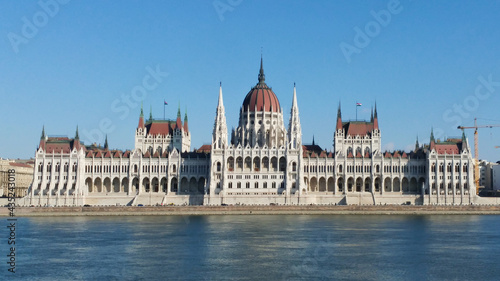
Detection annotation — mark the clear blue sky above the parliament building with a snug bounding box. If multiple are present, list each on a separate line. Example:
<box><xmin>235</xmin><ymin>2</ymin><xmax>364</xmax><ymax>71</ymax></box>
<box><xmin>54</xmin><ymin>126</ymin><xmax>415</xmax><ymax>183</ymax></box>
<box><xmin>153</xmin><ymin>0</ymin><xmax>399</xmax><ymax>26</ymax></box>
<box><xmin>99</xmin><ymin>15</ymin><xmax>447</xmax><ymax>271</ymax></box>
<box><xmin>0</xmin><ymin>0</ymin><xmax>500</xmax><ymax>161</ymax></box>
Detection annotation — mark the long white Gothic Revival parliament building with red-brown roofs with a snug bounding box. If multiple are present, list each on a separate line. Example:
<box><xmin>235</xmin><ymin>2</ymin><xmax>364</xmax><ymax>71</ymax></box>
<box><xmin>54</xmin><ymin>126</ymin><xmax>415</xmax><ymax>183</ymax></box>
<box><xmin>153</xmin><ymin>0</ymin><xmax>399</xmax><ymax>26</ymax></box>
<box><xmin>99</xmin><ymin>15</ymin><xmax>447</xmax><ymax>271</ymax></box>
<box><xmin>24</xmin><ymin>59</ymin><xmax>477</xmax><ymax>206</ymax></box>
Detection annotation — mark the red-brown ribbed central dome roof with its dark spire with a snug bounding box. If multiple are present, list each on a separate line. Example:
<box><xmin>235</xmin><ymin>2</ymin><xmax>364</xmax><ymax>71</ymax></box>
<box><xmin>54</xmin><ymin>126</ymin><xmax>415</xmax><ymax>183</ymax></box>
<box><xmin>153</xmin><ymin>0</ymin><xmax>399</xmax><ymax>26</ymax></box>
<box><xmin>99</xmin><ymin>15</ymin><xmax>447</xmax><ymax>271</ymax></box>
<box><xmin>243</xmin><ymin>58</ymin><xmax>281</xmax><ymax>112</ymax></box>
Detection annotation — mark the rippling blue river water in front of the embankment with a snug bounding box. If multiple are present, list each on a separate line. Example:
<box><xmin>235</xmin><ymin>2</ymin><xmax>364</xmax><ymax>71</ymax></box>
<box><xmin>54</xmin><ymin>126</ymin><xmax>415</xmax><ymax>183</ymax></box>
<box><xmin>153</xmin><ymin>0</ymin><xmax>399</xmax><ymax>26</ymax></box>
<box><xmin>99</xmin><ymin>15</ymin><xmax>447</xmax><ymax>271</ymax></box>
<box><xmin>0</xmin><ymin>215</ymin><xmax>500</xmax><ymax>280</ymax></box>
